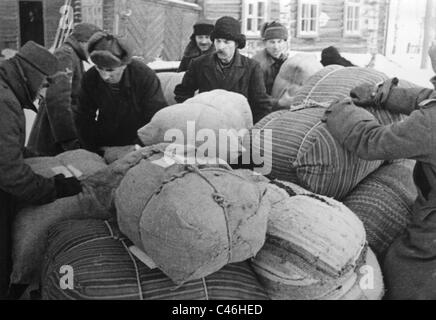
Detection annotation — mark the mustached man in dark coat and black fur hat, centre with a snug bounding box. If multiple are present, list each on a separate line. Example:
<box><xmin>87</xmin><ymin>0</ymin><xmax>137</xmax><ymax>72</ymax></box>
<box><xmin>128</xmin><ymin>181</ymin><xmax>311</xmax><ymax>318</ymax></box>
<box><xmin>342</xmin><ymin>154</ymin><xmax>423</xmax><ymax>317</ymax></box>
<box><xmin>174</xmin><ymin>17</ymin><xmax>271</xmax><ymax>122</ymax></box>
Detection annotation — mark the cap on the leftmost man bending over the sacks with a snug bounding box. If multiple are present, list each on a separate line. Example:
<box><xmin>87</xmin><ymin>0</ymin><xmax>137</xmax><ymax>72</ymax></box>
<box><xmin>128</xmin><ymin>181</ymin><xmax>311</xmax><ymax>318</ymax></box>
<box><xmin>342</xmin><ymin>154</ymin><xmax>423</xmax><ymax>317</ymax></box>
<box><xmin>16</xmin><ymin>41</ymin><xmax>58</xmax><ymax>76</ymax></box>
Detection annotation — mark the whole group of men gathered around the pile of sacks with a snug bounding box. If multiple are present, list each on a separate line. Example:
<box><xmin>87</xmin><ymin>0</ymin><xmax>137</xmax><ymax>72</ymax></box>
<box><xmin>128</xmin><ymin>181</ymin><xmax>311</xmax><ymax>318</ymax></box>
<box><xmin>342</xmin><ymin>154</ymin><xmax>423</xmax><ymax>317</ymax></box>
<box><xmin>0</xmin><ymin>12</ymin><xmax>436</xmax><ymax>299</ymax></box>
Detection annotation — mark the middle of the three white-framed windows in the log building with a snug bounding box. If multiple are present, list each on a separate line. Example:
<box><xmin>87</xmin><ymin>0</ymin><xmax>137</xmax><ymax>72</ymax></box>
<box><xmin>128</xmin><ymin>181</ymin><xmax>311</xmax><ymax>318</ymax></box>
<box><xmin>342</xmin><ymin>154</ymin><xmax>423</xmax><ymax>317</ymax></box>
<box><xmin>297</xmin><ymin>0</ymin><xmax>320</xmax><ymax>37</ymax></box>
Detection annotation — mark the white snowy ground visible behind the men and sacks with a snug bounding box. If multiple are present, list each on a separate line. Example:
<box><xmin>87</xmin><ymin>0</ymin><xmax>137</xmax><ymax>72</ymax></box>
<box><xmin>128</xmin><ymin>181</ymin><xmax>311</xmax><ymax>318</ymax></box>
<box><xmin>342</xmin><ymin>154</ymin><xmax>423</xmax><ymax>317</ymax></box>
<box><xmin>25</xmin><ymin>51</ymin><xmax>434</xmax><ymax>142</ymax></box>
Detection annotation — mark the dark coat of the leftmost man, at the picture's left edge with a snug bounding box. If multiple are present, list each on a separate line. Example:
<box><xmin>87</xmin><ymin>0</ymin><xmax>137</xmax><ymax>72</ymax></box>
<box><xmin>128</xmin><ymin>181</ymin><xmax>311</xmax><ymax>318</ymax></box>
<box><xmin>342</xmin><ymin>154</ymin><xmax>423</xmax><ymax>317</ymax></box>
<box><xmin>0</xmin><ymin>58</ymin><xmax>56</xmax><ymax>204</ymax></box>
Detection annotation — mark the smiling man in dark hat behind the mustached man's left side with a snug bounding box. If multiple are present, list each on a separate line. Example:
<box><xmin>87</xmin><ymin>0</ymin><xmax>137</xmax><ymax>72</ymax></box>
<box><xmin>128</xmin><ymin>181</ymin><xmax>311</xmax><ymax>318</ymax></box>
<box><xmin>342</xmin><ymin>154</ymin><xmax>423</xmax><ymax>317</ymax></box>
<box><xmin>177</xmin><ymin>20</ymin><xmax>215</xmax><ymax>72</ymax></box>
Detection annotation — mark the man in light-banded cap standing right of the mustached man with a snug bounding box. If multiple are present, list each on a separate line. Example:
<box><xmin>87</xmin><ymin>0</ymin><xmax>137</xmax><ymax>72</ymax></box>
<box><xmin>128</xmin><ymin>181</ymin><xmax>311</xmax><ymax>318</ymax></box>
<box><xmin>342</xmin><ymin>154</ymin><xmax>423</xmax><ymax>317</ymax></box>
<box><xmin>253</xmin><ymin>21</ymin><xmax>288</xmax><ymax>95</ymax></box>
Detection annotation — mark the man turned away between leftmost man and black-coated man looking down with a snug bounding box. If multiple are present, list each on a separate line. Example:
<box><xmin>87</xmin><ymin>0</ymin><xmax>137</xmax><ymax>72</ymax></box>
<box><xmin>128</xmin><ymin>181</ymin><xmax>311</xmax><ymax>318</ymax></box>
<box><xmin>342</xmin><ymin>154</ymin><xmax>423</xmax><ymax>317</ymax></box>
<box><xmin>27</xmin><ymin>23</ymin><xmax>101</xmax><ymax>156</ymax></box>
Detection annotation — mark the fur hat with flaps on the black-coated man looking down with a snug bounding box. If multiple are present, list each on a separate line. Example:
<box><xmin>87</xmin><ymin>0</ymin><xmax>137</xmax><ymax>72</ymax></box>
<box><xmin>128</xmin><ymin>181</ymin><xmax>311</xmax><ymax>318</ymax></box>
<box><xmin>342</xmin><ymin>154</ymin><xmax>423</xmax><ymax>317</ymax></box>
<box><xmin>88</xmin><ymin>32</ymin><xmax>133</xmax><ymax>69</ymax></box>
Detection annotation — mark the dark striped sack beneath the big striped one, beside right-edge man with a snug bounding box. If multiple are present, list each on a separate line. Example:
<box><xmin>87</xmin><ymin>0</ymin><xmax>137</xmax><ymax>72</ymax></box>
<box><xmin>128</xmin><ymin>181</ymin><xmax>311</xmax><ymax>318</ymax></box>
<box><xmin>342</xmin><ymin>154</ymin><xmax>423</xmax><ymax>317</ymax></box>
<box><xmin>344</xmin><ymin>160</ymin><xmax>417</xmax><ymax>261</ymax></box>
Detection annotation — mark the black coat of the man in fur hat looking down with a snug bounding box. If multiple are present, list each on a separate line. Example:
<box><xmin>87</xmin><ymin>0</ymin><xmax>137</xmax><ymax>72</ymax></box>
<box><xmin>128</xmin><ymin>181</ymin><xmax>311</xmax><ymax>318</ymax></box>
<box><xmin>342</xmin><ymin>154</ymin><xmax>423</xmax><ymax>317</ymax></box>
<box><xmin>76</xmin><ymin>60</ymin><xmax>168</xmax><ymax>152</ymax></box>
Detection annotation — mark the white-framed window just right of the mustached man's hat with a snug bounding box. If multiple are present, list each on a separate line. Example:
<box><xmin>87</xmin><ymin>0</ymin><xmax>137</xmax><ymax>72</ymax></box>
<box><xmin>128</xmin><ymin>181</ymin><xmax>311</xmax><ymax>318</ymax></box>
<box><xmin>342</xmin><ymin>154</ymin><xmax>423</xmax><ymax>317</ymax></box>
<box><xmin>242</xmin><ymin>0</ymin><xmax>268</xmax><ymax>36</ymax></box>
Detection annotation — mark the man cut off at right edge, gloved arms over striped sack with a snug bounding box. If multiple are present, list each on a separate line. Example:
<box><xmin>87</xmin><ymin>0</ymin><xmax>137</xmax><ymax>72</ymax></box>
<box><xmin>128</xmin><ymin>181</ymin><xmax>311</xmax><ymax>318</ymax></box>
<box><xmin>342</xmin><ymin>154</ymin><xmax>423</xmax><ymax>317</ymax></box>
<box><xmin>325</xmin><ymin>80</ymin><xmax>436</xmax><ymax>300</ymax></box>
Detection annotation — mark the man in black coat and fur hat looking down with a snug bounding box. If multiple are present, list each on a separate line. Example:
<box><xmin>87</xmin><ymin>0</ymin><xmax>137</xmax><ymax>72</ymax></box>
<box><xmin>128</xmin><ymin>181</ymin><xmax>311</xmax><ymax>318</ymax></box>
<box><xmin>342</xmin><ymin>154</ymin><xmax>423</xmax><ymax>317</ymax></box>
<box><xmin>76</xmin><ymin>32</ymin><xmax>167</xmax><ymax>153</ymax></box>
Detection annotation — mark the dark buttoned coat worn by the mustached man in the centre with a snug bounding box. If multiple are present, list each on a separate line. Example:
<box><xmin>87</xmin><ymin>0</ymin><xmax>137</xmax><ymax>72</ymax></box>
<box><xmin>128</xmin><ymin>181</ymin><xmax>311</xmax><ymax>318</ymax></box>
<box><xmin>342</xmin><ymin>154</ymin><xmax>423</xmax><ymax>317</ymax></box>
<box><xmin>174</xmin><ymin>51</ymin><xmax>271</xmax><ymax>122</ymax></box>
